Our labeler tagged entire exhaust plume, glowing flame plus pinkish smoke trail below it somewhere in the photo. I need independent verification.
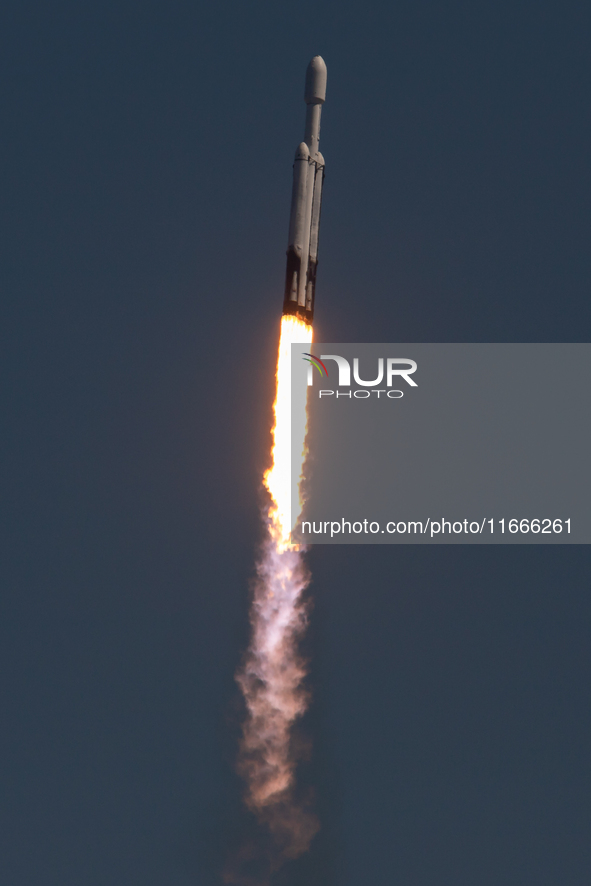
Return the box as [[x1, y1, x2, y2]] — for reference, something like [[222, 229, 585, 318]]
[[236, 316, 318, 869]]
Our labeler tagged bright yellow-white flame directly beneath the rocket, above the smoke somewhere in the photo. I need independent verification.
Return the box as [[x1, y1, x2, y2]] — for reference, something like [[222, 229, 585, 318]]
[[264, 316, 312, 551]]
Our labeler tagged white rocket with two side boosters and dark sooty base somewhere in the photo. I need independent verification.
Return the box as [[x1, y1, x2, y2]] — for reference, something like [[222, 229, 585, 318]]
[[283, 55, 326, 324]]
